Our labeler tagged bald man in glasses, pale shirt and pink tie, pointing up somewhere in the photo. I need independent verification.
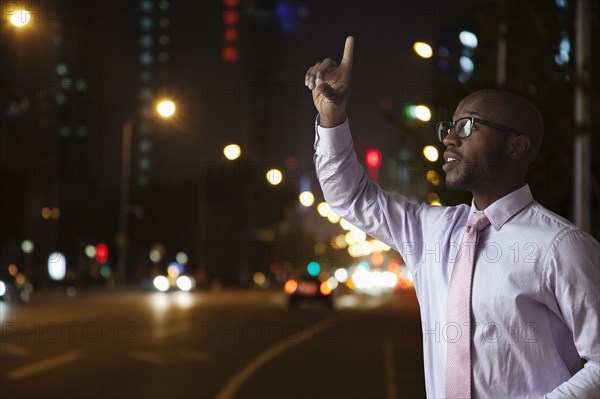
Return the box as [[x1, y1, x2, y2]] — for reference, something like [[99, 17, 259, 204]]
[[305, 37, 600, 398]]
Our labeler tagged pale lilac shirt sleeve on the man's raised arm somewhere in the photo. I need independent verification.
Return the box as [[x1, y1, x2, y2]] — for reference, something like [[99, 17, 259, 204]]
[[314, 117, 440, 267]]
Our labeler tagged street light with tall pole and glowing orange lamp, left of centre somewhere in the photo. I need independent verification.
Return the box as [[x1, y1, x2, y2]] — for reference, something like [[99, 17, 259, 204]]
[[117, 100, 175, 282]]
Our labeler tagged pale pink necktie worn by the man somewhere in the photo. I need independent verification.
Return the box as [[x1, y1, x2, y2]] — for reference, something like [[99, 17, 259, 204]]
[[446, 211, 490, 399]]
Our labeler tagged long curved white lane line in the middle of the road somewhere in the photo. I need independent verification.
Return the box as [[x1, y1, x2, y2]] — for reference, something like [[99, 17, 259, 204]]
[[216, 320, 331, 399]]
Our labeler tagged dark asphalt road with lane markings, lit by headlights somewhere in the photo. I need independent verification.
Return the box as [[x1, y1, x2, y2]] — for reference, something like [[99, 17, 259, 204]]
[[0, 291, 425, 399]]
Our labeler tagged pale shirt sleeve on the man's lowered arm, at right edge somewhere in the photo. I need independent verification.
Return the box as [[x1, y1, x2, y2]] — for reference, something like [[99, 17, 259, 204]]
[[545, 230, 600, 399]]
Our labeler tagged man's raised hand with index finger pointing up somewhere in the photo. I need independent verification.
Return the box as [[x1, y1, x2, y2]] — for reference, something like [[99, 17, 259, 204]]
[[304, 36, 354, 127]]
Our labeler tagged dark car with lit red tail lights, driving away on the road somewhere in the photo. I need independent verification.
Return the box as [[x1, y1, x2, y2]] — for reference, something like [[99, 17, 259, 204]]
[[284, 276, 333, 309]]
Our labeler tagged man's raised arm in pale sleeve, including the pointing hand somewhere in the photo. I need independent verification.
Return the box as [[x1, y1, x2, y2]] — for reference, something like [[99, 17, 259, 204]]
[[305, 37, 448, 265]]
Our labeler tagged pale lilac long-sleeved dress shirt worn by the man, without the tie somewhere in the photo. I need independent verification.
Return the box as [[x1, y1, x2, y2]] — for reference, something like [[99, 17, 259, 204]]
[[314, 120, 600, 398]]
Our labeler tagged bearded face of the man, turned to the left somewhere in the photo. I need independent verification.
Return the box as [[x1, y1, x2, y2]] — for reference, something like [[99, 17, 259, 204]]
[[442, 97, 507, 191]]
